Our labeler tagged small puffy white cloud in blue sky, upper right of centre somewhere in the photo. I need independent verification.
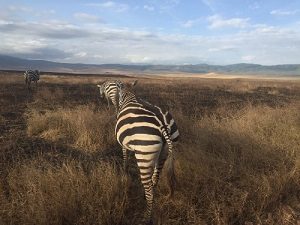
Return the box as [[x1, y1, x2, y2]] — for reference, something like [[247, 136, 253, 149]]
[[207, 15, 250, 29]]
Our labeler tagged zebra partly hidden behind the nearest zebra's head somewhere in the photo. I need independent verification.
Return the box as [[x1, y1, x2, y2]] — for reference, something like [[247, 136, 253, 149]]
[[97, 80, 124, 108]]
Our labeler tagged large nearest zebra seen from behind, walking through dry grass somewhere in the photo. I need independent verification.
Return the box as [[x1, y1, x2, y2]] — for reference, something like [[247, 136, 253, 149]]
[[98, 81, 179, 223]]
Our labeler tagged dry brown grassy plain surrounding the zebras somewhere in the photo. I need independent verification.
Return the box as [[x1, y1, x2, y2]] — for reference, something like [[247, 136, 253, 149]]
[[0, 72, 300, 225]]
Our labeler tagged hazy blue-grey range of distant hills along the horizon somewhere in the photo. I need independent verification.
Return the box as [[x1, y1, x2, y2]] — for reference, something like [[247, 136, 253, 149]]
[[0, 55, 300, 76]]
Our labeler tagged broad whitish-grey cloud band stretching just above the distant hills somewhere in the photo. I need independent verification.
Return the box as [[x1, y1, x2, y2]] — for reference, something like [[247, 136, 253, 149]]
[[0, 15, 300, 64]]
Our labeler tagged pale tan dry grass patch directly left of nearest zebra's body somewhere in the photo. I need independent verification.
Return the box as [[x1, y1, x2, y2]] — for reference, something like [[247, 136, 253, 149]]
[[27, 105, 115, 152]]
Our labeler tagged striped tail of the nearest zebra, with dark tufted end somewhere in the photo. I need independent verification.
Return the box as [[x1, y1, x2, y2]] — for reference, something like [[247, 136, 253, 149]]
[[162, 129, 177, 198]]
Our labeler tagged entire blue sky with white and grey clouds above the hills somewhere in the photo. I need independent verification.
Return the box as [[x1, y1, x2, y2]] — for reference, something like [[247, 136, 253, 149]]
[[0, 0, 300, 65]]
